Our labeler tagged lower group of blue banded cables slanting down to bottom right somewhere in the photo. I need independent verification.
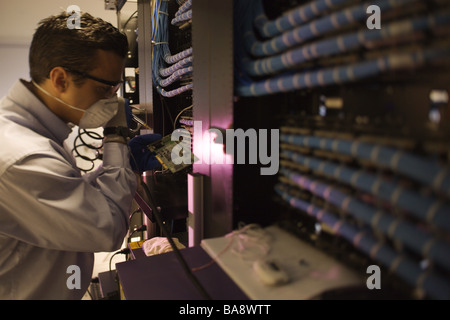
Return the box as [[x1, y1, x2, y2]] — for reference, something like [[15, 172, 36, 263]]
[[275, 127, 450, 299]]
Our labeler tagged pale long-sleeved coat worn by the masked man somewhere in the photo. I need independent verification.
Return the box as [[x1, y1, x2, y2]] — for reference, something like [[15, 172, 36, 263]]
[[0, 80, 137, 299]]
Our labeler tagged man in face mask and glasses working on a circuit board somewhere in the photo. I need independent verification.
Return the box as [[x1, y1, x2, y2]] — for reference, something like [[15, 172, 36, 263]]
[[0, 13, 160, 299]]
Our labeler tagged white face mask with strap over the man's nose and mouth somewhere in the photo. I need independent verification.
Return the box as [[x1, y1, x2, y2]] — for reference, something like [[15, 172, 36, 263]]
[[32, 81, 118, 129]]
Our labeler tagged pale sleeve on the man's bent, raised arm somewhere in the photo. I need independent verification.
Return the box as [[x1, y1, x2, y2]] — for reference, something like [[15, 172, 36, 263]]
[[0, 143, 136, 252]]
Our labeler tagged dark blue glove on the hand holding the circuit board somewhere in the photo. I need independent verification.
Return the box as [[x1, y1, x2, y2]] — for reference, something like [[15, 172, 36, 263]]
[[128, 134, 162, 173]]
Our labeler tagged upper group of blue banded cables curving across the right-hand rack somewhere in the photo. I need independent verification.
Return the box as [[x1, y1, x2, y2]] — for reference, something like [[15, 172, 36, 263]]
[[235, 0, 450, 96]]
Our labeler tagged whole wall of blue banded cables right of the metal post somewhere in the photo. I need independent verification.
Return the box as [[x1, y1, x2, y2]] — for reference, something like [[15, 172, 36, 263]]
[[234, 0, 450, 299]]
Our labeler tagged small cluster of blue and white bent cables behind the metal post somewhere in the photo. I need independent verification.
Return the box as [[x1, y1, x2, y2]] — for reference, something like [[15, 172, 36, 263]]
[[152, 0, 193, 97]]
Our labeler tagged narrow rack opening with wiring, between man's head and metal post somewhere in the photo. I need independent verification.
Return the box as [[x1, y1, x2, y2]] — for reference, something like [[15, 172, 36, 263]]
[[151, 0, 193, 139]]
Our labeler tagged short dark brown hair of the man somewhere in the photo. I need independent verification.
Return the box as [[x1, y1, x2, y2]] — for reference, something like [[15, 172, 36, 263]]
[[29, 12, 128, 85]]
